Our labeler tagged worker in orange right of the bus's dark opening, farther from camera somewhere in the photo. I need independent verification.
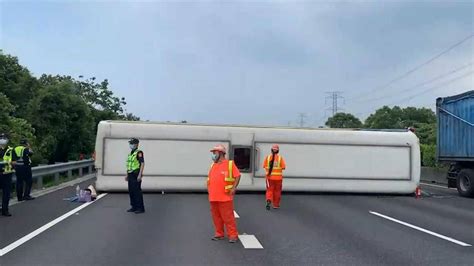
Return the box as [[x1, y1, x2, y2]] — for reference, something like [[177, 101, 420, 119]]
[[263, 144, 286, 210]]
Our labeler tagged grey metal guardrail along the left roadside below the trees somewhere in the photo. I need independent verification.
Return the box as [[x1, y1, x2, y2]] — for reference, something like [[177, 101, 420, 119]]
[[14, 160, 94, 189]]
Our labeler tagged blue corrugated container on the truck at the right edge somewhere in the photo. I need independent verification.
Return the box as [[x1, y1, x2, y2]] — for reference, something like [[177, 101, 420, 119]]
[[436, 91, 474, 161]]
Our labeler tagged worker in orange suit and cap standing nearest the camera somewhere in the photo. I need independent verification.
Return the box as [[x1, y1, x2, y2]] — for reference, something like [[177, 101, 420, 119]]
[[207, 145, 240, 243]]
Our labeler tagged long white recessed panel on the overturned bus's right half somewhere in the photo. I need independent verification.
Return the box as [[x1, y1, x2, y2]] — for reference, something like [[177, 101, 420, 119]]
[[255, 143, 411, 180]]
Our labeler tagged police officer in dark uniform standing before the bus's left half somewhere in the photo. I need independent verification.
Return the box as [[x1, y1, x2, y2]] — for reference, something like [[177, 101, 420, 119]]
[[125, 138, 145, 213]]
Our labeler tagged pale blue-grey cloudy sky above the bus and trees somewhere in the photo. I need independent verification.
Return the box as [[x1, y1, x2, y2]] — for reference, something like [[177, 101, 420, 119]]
[[0, 0, 474, 127]]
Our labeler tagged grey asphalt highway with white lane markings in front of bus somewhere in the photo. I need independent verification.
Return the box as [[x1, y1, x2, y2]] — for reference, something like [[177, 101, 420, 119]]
[[0, 182, 474, 266]]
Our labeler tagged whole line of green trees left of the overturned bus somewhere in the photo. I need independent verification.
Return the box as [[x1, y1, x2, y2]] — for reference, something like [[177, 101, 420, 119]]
[[0, 50, 139, 164]]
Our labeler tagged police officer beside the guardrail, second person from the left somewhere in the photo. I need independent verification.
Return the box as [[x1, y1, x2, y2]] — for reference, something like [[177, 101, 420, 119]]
[[15, 139, 35, 201]]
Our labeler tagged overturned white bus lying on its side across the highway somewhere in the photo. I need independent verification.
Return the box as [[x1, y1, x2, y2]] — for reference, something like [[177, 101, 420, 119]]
[[95, 121, 420, 194]]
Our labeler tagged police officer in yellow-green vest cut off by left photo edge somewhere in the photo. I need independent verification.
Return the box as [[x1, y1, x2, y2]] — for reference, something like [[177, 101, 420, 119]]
[[0, 133, 17, 216]]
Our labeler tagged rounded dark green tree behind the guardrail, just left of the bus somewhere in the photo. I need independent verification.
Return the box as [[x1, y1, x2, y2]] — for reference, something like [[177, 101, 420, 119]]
[[30, 80, 95, 163]]
